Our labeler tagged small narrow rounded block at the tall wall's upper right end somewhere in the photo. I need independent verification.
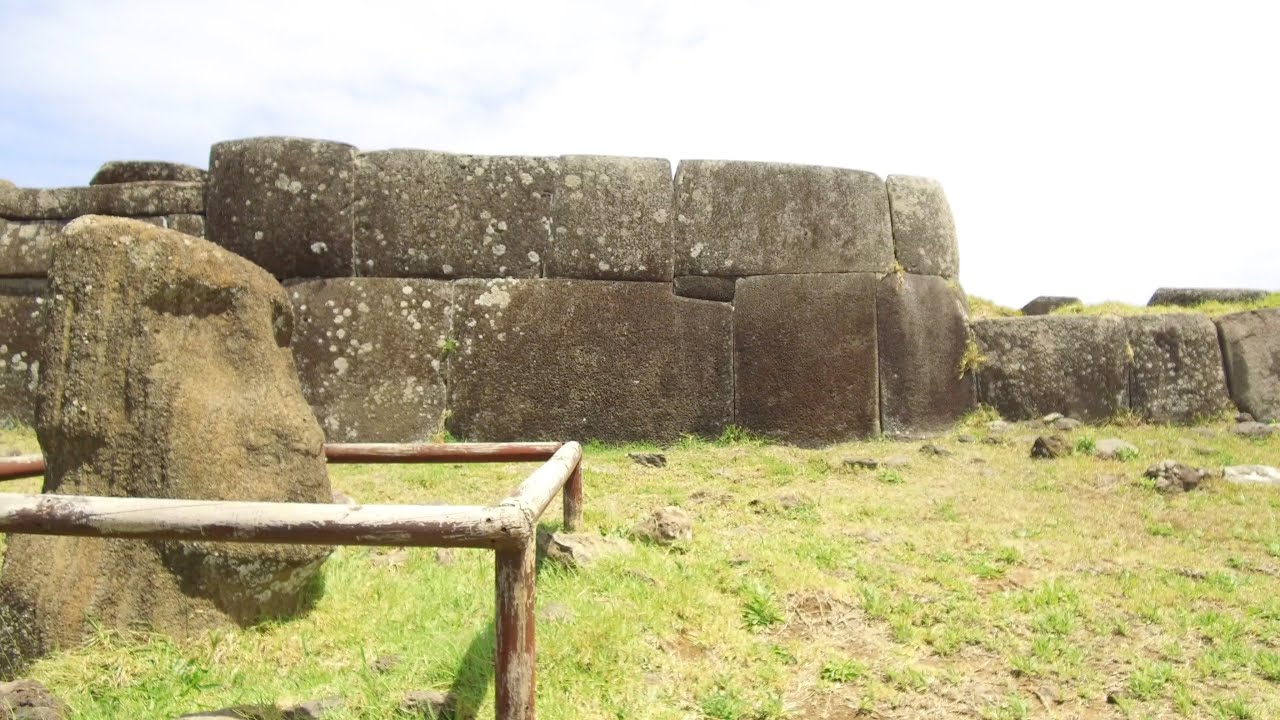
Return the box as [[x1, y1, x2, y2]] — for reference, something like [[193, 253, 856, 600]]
[[884, 176, 960, 278]]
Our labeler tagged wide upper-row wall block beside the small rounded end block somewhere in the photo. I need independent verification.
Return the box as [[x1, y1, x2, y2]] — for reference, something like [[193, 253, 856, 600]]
[[675, 160, 893, 275]]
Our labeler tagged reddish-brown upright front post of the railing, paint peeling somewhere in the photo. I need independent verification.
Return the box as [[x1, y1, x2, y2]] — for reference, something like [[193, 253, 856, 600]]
[[494, 541, 538, 720]]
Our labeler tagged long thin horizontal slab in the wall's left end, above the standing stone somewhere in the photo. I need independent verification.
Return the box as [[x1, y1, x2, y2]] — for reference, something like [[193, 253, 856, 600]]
[[0, 182, 205, 220]]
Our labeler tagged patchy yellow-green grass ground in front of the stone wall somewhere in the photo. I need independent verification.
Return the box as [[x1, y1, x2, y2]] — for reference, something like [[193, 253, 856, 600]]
[[0, 414, 1280, 720]]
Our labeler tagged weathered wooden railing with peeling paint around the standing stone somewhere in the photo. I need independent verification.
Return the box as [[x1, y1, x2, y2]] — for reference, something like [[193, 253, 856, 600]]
[[0, 442, 582, 720]]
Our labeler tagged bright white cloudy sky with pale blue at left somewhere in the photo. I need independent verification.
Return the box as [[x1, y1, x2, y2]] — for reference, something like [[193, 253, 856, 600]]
[[0, 0, 1280, 307]]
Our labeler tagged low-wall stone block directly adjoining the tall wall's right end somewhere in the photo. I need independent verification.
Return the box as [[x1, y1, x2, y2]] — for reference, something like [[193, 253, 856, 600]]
[[973, 315, 1129, 421]]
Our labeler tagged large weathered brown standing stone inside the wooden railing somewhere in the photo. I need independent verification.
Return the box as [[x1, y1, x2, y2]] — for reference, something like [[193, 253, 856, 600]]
[[0, 217, 330, 676]]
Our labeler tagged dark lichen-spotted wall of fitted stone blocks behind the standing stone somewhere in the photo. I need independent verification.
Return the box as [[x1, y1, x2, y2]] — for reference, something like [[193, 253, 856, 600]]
[[0, 132, 1261, 445]]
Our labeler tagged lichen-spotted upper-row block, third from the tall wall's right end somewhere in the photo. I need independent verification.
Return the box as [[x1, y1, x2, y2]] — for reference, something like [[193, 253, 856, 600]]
[[545, 155, 673, 281]]
